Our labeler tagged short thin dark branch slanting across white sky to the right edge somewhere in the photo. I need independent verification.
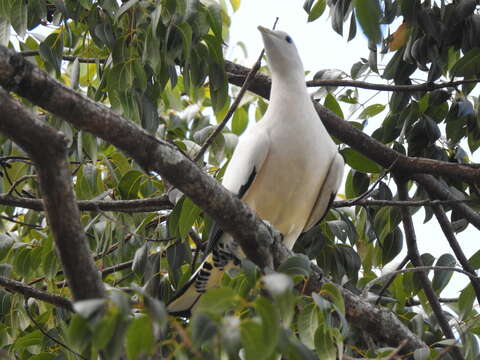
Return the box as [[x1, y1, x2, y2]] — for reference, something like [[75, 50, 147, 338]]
[[433, 205, 480, 305]]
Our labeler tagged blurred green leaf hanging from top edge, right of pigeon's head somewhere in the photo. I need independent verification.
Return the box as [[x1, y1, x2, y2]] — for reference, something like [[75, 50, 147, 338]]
[[354, 0, 382, 44]]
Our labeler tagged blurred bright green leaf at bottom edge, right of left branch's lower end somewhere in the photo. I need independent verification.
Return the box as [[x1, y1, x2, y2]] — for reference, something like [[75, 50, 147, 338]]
[[126, 315, 154, 360]]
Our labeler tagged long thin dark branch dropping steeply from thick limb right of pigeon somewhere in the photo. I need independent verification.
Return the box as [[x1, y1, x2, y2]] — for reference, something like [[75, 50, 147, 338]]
[[396, 179, 463, 360]]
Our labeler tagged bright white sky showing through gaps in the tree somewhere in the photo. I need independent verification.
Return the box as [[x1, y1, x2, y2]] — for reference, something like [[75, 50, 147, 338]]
[[226, 0, 480, 297]]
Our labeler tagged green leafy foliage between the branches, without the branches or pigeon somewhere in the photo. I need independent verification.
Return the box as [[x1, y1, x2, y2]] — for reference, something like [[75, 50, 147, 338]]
[[0, 0, 480, 359]]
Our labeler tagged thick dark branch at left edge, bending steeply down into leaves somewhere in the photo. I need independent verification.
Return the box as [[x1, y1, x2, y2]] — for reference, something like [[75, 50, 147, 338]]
[[0, 89, 105, 300]]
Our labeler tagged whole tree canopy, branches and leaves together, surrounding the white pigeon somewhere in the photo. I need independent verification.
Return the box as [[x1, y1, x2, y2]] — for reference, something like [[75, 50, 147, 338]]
[[0, 0, 480, 360]]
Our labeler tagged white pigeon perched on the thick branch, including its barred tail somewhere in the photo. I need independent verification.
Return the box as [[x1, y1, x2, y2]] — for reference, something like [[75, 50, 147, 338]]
[[167, 26, 344, 315]]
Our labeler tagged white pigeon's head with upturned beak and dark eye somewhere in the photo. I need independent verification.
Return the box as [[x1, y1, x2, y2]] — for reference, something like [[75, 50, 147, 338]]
[[258, 26, 305, 81]]
